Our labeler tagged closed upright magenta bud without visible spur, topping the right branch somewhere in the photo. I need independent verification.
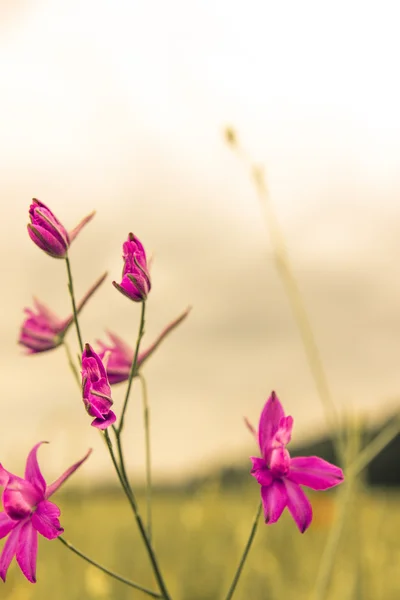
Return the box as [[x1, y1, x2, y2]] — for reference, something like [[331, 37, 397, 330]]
[[113, 233, 151, 302]]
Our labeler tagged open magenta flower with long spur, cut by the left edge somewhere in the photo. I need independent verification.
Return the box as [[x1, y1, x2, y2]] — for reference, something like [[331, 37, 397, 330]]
[[0, 442, 91, 583]]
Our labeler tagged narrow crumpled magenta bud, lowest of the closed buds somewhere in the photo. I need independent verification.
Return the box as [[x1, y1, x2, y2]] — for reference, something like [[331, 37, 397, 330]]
[[82, 344, 116, 429]]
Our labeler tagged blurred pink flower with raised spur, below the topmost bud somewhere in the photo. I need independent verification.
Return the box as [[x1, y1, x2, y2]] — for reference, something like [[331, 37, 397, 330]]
[[18, 273, 107, 354]]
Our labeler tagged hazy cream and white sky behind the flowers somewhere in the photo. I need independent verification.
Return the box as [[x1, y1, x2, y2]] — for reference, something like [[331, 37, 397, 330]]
[[0, 0, 400, 476]]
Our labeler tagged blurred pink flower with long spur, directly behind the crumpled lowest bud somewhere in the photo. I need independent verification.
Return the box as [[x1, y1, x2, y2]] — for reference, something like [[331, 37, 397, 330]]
[[98, 308, 190, 385]]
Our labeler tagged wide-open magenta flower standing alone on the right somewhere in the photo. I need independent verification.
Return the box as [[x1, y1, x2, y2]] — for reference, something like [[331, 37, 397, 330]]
[[250, 392, 343, 533]]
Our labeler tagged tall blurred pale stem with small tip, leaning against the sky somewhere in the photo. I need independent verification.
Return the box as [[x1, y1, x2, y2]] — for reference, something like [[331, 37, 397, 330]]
[[225, 128, 344, 461]]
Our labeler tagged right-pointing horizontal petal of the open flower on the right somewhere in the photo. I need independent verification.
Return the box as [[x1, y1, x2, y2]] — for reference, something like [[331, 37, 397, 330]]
[[287, 456, 344, 490]]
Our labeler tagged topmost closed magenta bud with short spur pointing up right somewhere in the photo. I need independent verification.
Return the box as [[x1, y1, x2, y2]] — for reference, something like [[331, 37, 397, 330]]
[[28, 198, 95, 258]]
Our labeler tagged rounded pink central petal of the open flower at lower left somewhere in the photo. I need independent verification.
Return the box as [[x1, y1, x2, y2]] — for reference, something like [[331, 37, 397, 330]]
[[3, 474, 42, 519]]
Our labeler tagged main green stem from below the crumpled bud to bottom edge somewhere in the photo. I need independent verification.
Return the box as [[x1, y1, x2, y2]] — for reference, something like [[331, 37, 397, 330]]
[[104, 428, 171, 600]]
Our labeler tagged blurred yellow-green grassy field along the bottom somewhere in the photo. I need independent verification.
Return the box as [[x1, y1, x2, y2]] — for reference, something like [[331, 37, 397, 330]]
[[0, 481, 400, 600]]
